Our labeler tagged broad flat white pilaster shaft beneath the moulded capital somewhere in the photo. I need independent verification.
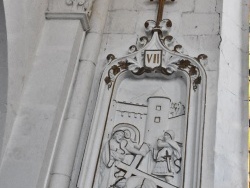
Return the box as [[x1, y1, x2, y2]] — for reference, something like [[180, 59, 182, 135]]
[[0, 8, 85, 188]]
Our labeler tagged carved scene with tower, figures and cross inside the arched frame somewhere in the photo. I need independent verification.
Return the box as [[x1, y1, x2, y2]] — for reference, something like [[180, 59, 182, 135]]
[[96, 78, 187, 187]]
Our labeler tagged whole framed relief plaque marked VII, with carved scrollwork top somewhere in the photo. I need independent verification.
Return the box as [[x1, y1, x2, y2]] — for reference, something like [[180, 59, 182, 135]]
[[79, 15, 206, 188]]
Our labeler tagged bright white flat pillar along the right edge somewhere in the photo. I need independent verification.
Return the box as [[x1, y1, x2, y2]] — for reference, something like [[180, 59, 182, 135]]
[[214, 0, 249, 188]]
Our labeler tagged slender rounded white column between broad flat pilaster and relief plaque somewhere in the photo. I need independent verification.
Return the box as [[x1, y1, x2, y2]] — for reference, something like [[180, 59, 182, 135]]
[[45, 0, 109, 188]]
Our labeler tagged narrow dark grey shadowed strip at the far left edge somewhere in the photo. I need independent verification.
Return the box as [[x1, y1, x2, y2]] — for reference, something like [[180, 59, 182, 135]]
[[0, 1, 8, 162]]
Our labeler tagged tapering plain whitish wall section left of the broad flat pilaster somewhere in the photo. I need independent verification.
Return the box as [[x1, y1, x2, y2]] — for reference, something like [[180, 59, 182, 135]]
[[4, 0, 48, 156]]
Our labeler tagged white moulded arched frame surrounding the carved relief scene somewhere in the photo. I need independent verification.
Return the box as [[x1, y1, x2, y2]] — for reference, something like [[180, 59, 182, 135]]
[[79, 25, 207, 188]]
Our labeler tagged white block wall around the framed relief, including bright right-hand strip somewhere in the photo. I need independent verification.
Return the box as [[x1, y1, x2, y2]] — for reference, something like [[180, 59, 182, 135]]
[[72, 0, 248, 188]]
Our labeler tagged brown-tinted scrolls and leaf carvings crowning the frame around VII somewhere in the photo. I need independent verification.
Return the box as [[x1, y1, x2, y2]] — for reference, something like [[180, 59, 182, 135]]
[[105, 19, 207, 91]]
